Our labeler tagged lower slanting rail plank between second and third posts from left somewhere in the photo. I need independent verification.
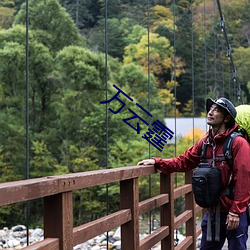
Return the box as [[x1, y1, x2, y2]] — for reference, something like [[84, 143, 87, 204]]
[[140, 226, 169, 250]]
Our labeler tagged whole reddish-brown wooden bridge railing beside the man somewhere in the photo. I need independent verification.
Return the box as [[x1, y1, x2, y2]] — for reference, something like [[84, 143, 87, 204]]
[[0, 166, 201, 250]]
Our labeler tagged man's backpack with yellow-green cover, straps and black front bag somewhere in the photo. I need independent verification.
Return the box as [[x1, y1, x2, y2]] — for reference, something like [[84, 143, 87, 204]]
[[192, 105, 250, 241]]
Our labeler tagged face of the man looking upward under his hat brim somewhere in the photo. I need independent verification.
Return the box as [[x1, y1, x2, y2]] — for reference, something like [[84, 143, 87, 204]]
[[207, 104, 225, 128]]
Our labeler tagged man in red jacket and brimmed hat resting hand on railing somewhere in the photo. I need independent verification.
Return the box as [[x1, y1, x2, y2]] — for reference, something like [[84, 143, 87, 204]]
[[138, 97, 250, 250]]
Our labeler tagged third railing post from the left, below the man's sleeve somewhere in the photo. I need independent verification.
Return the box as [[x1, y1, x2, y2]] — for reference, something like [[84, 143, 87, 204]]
[[160, 173, 174, 250]]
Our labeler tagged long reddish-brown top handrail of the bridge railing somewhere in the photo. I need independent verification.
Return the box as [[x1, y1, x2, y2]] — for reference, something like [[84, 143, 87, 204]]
[[0, 166, 156, 206]]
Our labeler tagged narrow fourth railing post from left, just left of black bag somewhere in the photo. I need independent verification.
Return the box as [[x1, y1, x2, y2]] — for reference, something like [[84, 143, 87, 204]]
[[185, 172, 196, 250]]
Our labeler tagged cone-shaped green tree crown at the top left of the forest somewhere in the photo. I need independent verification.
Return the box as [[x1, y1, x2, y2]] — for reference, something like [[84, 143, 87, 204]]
[[14, 0, 84, 52]]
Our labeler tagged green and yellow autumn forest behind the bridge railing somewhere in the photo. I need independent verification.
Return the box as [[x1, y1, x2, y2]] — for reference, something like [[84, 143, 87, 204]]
[[0, 0, 250, 228]]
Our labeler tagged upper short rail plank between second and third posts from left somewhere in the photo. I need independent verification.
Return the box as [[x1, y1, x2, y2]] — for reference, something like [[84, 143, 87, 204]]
[[139, 194, 169, 215]]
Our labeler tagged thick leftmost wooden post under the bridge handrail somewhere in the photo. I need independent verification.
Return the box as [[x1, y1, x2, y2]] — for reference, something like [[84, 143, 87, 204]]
[[44, 192, 73, 250]]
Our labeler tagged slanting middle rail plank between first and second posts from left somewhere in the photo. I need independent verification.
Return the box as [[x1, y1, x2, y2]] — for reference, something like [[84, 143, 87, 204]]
[[73, 209, 131, 246]]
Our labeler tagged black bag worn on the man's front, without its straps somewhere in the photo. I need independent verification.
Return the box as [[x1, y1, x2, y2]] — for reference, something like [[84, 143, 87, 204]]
[[192, 163, 221, 208]]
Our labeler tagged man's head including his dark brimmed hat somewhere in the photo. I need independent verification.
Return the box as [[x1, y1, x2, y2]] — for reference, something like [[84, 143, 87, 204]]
[[206, 97, 237, 128]]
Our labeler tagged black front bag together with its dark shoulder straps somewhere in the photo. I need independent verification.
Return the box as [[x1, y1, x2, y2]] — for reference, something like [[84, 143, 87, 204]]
[[192, 132, 242, 208]]
